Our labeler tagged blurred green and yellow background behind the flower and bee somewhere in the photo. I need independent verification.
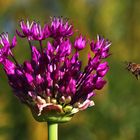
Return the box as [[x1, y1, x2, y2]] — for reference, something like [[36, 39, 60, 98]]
[[0, 0, 140, 140]]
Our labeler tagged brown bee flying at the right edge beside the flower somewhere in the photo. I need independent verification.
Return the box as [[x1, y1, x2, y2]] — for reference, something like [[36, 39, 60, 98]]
[[126, 62, 140, 80]]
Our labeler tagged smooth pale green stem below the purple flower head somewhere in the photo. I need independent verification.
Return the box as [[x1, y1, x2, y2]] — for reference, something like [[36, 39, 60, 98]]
[[48, 122, 58, 140]]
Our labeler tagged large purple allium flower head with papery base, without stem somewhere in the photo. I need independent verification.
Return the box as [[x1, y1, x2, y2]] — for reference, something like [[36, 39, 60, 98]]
[[0, 17, 111, 121]]
